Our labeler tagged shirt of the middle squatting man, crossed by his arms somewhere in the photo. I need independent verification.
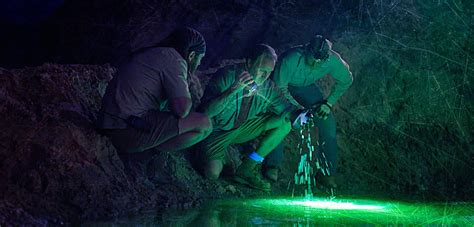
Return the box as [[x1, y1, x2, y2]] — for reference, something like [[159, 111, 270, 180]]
[[202, 64, 293, 130]]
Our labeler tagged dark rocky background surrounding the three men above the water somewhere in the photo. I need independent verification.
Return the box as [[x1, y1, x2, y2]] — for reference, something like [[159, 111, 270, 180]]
[[0, 0, 474, 223]]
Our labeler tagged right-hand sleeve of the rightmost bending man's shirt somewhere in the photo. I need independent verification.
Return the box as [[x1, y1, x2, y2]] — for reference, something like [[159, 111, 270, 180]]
[[327, 53, 353, 104]]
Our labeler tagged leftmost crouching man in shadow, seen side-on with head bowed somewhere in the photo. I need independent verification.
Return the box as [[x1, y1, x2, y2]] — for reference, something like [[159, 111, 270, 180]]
[[98, 28, 211, 153]]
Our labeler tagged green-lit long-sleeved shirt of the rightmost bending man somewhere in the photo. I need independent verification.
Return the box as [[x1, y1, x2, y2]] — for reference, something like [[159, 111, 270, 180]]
[[273, 46, 353, 107]]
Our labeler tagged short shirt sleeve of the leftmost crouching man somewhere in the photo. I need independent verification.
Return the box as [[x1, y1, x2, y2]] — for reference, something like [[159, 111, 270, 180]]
[[162, 59, 191, 99]]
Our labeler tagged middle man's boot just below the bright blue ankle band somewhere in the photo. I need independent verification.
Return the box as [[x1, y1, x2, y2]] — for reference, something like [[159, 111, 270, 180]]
[[234, 158, 271, 192]]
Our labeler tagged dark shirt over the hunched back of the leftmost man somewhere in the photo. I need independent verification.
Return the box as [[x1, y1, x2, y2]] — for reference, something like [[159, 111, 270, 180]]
[[100, 47, 190, 128]]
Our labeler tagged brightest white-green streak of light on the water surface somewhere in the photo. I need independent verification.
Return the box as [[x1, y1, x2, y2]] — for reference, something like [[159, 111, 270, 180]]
[[289, 201, 383, 210]]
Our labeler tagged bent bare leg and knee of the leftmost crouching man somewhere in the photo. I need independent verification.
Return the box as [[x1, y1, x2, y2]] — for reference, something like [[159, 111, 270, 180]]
[[157, 112, 212, 151]]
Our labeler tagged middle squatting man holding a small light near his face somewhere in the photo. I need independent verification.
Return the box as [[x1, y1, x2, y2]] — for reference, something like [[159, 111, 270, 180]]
[[199, 44, 292, 191]]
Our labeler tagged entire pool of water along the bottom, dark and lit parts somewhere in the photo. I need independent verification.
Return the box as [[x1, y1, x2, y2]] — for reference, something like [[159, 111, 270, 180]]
[[85, 198, 474, 227]]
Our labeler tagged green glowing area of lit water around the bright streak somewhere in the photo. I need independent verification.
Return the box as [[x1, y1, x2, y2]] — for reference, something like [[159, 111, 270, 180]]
[[218, 198, 474, 226]]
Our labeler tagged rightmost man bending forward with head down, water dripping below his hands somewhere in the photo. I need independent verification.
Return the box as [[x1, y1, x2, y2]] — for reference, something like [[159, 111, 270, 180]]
[[266, 35, 353, 188]]
